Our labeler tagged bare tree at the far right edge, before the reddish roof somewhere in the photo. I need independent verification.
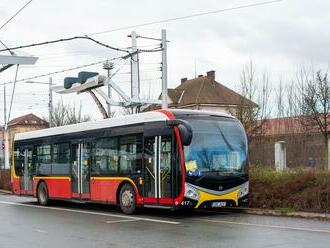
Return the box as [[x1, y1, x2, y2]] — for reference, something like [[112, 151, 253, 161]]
[[300, 71, 330, 170]]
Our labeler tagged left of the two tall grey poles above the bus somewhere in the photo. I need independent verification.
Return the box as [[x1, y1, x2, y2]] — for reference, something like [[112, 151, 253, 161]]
[[130, 31, 140, 101]]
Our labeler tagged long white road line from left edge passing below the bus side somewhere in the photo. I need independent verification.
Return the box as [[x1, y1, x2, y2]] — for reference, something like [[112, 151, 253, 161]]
[[0, 201, 181, 225]]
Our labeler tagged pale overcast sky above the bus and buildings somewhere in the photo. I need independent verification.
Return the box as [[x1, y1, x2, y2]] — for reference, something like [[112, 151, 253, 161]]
[[0, 0, 330, 123]]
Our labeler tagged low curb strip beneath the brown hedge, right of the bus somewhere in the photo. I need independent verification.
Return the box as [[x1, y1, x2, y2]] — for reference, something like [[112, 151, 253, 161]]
[[240, 208, 330, 220]]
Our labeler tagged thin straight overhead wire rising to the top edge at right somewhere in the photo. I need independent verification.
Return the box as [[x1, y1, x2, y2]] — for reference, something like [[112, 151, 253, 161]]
[[87, 0, 283, 36]]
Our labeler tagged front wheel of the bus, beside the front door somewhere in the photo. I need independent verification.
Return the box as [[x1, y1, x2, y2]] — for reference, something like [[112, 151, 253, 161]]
[[119, 183, 136, 214]]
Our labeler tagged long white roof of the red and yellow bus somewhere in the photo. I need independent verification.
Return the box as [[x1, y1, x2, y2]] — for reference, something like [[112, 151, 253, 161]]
[[14, 109, 233, 141]]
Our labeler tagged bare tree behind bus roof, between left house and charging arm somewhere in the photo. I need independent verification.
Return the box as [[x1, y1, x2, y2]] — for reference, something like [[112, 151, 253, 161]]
[[47, 101, 91, 127]]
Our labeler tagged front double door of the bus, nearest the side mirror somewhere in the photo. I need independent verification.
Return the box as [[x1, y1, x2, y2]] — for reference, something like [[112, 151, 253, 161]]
[[144, 136, 174, 206]]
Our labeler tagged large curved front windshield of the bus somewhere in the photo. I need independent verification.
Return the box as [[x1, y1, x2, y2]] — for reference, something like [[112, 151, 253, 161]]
[[184, 117, 247, 176]]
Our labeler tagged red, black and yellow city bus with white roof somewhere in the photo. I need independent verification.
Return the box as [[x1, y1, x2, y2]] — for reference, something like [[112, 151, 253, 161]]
[[12, 110, 249, 214]]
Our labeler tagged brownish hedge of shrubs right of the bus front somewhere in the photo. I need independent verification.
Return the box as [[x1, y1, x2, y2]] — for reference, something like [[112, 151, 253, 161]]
[[250, 166, 330, 212]]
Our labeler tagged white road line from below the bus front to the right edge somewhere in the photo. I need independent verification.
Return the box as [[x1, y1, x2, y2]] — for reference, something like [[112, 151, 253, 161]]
[[195, 219, 330, 233]]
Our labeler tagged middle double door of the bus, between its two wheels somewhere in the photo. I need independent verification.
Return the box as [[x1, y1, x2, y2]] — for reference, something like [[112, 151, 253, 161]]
[[71, 143, 90, 200]]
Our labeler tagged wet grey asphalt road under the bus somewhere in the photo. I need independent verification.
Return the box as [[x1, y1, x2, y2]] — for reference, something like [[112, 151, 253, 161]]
[[0, 195, 330, 248]]
